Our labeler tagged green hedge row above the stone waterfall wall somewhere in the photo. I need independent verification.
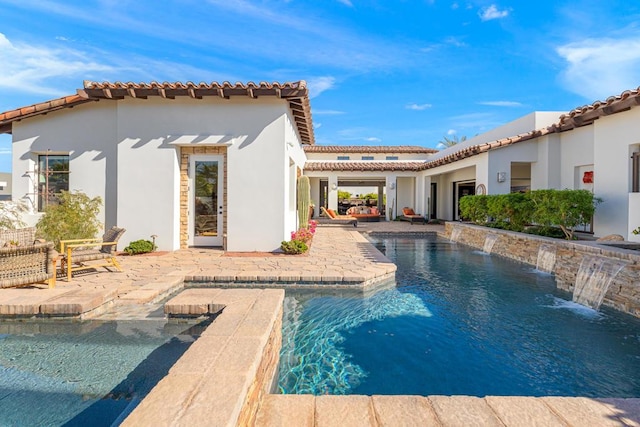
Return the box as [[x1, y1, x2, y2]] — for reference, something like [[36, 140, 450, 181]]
[[460, 190, 602, 240]]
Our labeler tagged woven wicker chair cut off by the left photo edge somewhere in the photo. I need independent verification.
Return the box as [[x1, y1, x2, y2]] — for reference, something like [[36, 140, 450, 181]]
[[0, 227, 58, 288]]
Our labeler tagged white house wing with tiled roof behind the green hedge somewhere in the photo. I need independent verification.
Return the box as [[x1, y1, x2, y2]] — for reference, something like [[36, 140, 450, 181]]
[[304, 88, 640, 241]]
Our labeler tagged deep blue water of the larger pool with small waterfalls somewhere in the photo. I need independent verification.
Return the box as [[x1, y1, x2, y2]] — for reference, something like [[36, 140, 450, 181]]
[[279, 237, 640, 397]]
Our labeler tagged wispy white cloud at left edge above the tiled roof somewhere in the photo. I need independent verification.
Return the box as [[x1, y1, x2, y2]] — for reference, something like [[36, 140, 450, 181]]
[[0, 33, 114, 96]]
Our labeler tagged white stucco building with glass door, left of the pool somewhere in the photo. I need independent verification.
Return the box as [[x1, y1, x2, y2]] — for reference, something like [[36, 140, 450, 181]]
[[0, 81, 314, 251]]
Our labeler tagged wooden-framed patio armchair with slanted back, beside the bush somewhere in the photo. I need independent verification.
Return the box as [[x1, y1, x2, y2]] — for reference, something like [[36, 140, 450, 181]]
[[60, 227, 126, 282]]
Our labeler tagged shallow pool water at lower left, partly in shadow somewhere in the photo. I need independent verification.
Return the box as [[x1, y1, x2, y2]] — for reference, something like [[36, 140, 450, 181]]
[[0, 319, 208, 426]]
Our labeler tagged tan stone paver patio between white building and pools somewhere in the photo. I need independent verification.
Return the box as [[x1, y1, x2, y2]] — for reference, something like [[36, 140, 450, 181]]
[[0, 222, 430, 317]]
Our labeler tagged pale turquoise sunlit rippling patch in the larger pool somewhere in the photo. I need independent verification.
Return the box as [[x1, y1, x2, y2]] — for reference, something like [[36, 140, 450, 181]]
[[279, 289, 432, 395]]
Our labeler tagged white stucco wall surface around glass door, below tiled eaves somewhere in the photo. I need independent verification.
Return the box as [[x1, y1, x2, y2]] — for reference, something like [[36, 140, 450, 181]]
[[13, 97, 305, 251]]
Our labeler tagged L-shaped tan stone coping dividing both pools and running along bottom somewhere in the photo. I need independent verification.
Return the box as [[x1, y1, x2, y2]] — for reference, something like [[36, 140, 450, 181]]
[[122, 288, 640, 427]]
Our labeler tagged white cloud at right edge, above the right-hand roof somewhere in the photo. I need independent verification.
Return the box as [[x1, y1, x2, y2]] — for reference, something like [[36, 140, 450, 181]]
[[556, 34, 640, 100]]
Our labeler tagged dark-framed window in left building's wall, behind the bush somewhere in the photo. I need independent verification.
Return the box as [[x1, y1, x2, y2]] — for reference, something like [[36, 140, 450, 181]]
[[38, 154, 69, 212]]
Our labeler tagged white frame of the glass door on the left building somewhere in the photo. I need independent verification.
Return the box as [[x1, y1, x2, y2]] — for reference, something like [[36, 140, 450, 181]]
[[187, 154, 225, 246]]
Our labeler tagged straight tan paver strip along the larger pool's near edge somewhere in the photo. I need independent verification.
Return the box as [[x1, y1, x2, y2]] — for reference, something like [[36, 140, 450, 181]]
[[256, 394, 640, 427]]
